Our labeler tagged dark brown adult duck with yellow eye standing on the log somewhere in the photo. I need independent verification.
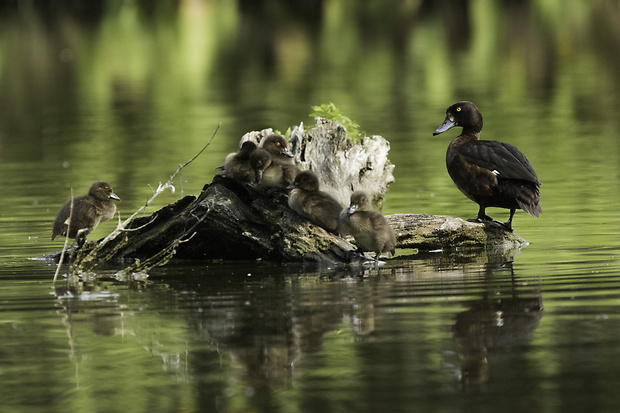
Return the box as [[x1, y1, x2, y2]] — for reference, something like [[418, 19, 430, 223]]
[[433, 101, 541, 231]]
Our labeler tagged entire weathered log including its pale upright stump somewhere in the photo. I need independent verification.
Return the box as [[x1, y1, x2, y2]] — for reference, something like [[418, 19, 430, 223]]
[[51, 119, 526, 273]]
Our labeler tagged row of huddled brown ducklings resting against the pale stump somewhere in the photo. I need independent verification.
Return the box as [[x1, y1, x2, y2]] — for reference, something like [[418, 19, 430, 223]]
[[224, 134, 396, 260]]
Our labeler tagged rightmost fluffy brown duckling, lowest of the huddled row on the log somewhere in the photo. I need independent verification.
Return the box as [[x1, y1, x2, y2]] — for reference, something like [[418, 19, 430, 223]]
[[340, 191, 396, 262]]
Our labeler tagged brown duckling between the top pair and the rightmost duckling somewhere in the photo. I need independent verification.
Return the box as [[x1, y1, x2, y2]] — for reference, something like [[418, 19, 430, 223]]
[[288, 171, 342, 234]]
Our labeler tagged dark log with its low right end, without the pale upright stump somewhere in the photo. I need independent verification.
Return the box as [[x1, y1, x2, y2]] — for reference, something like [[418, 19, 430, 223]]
[[57, 175, 526, 272]]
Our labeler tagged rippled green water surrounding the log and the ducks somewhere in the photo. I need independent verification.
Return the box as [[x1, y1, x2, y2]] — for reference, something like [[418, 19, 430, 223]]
[[0, 0, 620, 412]]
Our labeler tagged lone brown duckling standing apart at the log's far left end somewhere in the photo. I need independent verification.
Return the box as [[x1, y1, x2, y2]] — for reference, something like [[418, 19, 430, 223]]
[[52, 181, 120, 248]]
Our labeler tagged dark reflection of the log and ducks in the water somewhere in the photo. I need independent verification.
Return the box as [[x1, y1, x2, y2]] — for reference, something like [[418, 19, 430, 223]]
[[46, 246, 542, 408]]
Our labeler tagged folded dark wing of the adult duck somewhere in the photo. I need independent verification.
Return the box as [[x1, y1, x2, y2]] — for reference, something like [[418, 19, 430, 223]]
[[459, 141, 540, 185]]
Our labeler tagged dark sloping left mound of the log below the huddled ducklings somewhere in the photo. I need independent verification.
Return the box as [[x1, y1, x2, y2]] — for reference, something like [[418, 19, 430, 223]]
[[63, 175, 352, 271]]
